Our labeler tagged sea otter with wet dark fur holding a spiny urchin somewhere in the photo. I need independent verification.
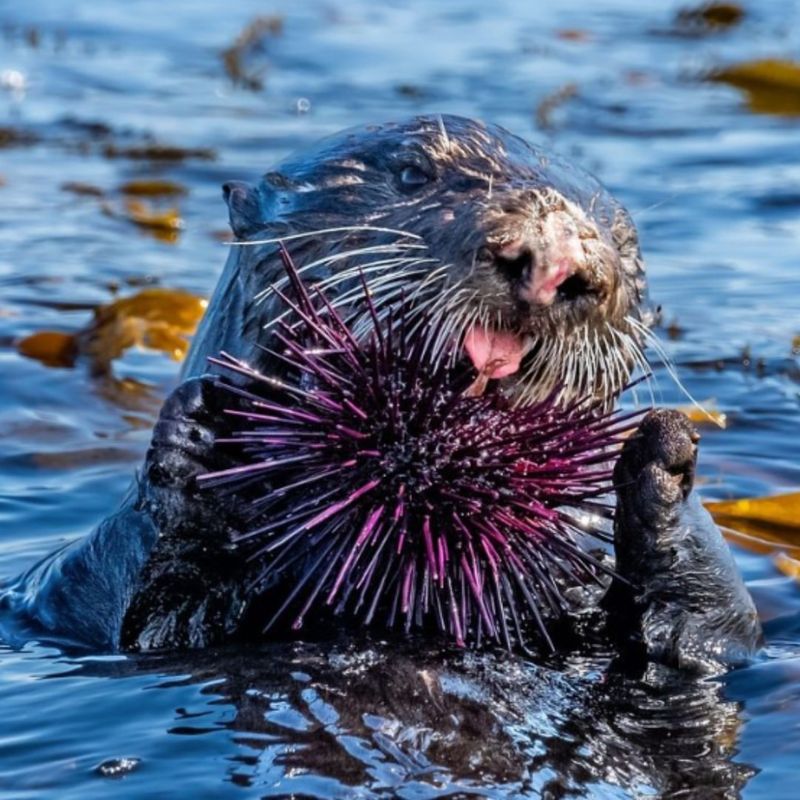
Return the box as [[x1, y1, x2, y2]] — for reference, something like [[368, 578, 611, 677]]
[[0, 116, 758, 665]]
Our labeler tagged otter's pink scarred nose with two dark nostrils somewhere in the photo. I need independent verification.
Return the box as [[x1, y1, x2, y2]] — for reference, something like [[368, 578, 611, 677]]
[[492, 239, 596, 306]]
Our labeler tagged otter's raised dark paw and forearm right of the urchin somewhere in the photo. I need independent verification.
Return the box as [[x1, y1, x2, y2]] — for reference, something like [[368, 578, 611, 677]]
[[604, 409, 761, 671]]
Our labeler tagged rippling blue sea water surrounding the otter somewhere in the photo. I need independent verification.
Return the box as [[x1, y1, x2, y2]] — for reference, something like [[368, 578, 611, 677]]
[[0, 0, 800, 799]]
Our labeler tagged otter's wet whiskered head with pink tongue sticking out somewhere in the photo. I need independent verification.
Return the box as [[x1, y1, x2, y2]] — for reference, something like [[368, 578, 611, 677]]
[[216, 116, 645, 403]]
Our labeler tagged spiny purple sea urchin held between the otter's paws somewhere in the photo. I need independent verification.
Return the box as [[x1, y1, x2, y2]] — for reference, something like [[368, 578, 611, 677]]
[[202, 251, 632, 647]]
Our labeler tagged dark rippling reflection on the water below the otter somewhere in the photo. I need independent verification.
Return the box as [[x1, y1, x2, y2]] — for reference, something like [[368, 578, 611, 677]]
[[51, 642, 755, 798]]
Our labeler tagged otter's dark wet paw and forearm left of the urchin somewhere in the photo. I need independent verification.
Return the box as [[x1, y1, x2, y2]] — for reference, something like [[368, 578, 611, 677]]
[[120, 376, 248, 650]]
